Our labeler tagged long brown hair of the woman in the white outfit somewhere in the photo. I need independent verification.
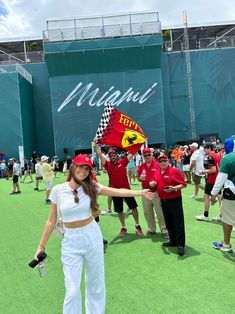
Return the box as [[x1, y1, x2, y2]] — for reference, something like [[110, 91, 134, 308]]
[[67, 164, 100, 217]]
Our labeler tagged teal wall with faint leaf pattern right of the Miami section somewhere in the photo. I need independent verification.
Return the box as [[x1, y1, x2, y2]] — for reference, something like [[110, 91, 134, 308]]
[[162, 48, 235, 145]]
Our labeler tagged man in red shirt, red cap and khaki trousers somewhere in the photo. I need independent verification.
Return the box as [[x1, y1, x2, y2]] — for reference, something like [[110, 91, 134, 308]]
[[137, 148, 168, 238]]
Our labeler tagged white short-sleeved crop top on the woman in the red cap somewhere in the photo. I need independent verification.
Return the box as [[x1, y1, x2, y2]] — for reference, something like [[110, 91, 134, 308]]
[[49, 182, 102, 222]]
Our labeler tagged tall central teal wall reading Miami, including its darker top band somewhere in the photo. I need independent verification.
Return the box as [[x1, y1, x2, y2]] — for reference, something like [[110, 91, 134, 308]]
[[45, 36, 165, 156]]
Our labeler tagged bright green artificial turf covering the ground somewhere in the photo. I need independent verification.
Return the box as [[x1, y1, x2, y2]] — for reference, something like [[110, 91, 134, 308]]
[[0, 174, 235, 314]]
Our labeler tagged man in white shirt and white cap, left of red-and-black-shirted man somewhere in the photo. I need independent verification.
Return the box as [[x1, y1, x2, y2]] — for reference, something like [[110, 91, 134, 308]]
[[189, 143, 205, 200]]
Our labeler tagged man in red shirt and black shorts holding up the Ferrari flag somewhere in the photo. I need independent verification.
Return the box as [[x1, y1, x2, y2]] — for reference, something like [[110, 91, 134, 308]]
[[96, 145, 143, 237]]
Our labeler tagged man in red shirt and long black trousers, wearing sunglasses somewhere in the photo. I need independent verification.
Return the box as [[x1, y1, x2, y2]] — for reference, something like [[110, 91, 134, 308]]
[[149, 154, 187, 256]]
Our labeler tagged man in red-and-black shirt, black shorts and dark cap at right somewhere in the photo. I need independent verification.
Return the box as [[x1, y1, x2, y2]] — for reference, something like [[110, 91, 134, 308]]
[[195, 143, 221, 221]]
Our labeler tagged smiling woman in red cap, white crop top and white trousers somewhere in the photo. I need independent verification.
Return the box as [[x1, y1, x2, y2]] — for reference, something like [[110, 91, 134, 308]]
[[35, 155, 152, 314]]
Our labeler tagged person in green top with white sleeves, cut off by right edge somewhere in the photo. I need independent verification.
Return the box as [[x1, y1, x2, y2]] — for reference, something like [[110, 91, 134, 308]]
[[211, 137, 235, 253]]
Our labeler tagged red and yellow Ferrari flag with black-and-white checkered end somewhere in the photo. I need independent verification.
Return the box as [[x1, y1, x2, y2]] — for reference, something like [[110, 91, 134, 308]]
[[94, 104, 148, 154]]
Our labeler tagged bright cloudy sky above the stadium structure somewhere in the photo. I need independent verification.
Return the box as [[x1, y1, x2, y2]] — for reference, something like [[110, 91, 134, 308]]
[[0, 0, 235, 38]]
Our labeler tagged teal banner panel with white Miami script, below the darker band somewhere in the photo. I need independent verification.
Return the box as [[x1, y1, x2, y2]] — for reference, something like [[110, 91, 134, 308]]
[[50, 69, 165, 155]]
